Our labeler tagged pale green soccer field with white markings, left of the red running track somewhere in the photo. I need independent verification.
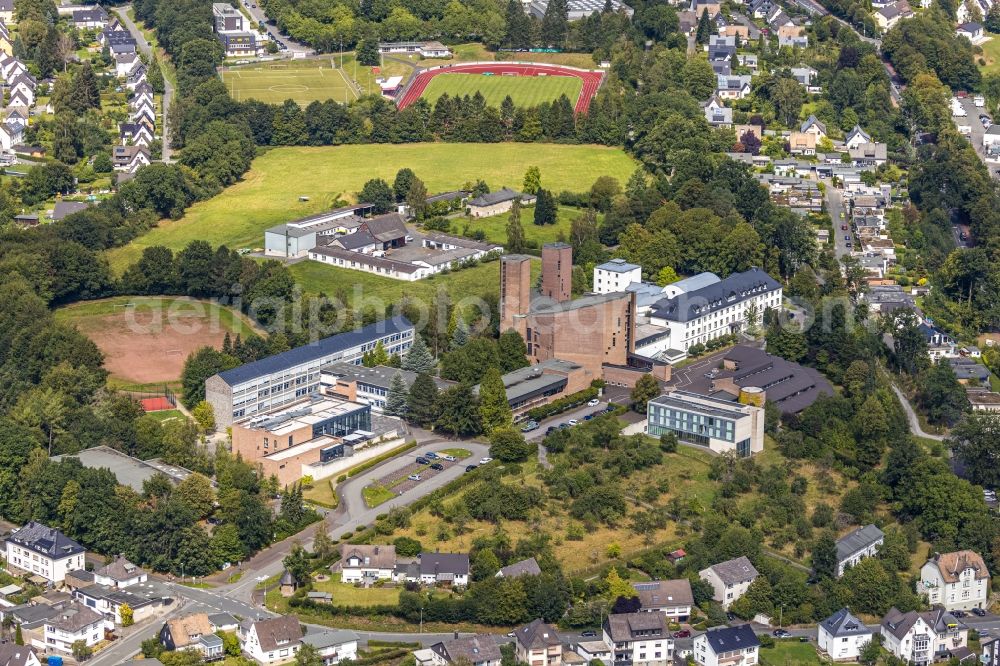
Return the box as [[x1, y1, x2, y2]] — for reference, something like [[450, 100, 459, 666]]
[[222, 59, 358, 106]]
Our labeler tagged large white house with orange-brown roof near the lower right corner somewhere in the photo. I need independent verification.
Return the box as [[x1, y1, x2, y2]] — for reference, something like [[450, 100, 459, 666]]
[[917, 550, 990, 610]]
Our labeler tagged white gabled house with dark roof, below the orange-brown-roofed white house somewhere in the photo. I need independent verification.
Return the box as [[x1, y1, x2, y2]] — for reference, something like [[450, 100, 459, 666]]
[[881, 607, 969, 666]]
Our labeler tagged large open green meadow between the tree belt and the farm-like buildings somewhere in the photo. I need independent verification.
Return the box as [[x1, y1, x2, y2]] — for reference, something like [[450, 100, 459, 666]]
[[108, 143, 636, 276]]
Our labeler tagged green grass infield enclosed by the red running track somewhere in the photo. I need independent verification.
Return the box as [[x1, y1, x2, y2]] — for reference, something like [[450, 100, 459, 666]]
[[423, 73, 583, 106]]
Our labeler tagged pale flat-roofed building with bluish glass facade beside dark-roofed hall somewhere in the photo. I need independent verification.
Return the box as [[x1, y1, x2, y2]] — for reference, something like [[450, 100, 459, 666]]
[[646, 390, 764, 457]]
